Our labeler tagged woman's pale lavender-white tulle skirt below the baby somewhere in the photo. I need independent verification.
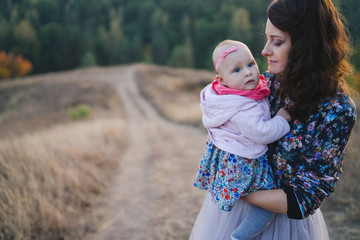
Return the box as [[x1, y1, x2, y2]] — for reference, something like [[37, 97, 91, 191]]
[[190, 193, 329, 240]]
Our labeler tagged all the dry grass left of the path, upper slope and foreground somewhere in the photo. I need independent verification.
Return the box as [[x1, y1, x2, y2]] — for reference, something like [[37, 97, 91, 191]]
[[0, 69, 126, 240]]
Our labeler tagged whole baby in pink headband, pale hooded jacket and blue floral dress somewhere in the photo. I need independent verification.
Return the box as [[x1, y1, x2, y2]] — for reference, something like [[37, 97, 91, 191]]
[[194, 40, 291, 240]]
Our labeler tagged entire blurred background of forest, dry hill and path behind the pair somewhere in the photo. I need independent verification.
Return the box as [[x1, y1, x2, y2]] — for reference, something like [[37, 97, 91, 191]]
[[0, 0, 360, 240]]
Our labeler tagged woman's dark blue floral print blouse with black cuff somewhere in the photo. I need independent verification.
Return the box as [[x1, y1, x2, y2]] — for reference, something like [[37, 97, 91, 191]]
[[264, 72, 356, 218]]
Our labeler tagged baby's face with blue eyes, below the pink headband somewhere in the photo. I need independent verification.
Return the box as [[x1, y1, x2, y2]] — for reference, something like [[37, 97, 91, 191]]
[[218, 48, 260, 90]]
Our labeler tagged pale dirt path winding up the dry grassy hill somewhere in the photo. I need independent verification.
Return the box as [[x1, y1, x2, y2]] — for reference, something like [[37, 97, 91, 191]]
[[86, 65, 205, 240]]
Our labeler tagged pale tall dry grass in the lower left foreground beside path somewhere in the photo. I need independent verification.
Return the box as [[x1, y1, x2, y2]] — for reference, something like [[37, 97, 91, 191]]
[[0, 119, 126, 240]]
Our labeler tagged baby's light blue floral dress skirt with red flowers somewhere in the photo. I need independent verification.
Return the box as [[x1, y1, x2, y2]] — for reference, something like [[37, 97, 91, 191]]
[[194, 137, 275, 211]]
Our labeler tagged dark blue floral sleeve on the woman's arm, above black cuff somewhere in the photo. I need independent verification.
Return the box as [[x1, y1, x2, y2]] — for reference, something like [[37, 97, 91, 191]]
[[286, 103, 355, 217]]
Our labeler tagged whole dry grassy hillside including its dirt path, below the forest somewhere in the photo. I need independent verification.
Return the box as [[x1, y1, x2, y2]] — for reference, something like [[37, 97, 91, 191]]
[[0, 64, 360, 240]]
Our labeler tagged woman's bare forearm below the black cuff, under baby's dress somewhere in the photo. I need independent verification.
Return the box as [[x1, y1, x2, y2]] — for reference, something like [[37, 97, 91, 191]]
[[243, 189, 288, 214]]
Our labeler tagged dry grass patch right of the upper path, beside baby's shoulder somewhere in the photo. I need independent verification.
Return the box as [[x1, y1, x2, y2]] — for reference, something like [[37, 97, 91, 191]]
[[137, 66, 214, 126]]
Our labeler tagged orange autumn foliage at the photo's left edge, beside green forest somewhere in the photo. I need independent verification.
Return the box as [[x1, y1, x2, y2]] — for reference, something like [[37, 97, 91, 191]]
[[0, 51, 32, 79]]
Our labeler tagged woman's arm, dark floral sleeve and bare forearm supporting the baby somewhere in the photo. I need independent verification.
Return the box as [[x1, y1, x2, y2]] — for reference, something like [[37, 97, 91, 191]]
[[244, 98, 356, 219]]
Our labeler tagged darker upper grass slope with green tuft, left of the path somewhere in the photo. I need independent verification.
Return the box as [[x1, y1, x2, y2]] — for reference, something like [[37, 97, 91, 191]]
[[0, 70, 124, 138]]
